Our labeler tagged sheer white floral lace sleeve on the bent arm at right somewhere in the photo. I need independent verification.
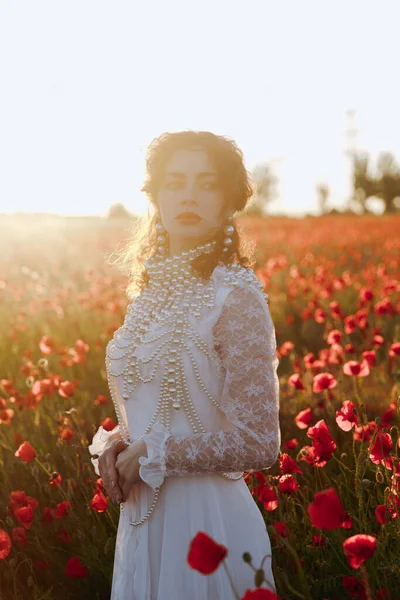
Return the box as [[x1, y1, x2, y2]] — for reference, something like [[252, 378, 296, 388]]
[[140, 285, 281, 483]]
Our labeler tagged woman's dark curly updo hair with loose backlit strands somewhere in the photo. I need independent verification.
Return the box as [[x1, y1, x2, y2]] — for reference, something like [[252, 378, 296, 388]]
[[104, 130, 256, 298]]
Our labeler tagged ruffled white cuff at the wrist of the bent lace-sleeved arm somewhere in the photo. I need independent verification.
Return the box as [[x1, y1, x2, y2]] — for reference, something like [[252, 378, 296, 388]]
[[139, 421, 171, 490]]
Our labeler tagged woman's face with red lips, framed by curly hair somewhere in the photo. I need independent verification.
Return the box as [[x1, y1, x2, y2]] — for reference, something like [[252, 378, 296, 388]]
[[158, 149, 227, 243]]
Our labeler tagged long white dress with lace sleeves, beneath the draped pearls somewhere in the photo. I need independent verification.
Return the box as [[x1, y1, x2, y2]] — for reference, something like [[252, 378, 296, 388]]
[[89, 265, 281, 600]]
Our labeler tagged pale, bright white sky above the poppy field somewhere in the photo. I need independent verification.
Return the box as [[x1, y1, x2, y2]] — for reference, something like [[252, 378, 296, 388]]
[[0, 0, 400, 216]]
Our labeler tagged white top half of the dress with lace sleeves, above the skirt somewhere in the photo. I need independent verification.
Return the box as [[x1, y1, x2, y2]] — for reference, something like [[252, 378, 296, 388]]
[[91, 265, 281, 489]]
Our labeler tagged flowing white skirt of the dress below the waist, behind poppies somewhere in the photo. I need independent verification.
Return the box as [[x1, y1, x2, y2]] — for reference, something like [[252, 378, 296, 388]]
[[111, 473, 275, 600]]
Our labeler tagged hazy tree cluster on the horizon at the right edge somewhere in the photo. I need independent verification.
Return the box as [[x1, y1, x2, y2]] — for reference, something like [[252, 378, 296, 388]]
[[353, 152, 400, 213]]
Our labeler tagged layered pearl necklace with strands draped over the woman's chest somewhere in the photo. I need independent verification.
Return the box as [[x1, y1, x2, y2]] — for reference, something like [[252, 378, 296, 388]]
[[106, 241, 267, 526]]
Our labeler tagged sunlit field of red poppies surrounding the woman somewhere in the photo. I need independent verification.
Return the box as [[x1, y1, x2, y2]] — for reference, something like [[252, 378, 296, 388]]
[[0, 215, 400, 600]]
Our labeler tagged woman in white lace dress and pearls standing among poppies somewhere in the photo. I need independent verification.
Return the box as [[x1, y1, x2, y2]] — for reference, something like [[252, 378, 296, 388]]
[[89, 131, 281, 600]]
